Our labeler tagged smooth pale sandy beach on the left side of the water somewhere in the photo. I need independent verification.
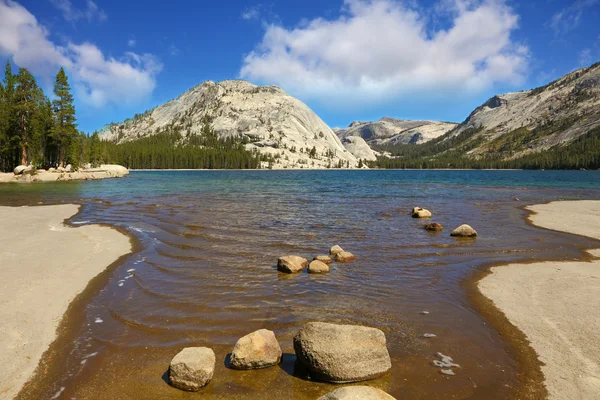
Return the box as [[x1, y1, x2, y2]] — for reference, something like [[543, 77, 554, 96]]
[[0, 204, 132, 399]]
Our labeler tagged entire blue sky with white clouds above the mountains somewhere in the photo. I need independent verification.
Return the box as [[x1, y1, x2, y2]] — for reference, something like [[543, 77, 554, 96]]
[[0, 0, 600, 133]]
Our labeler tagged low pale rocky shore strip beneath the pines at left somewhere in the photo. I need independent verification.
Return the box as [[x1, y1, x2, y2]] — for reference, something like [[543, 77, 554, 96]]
[[0, 164, 129, 183]]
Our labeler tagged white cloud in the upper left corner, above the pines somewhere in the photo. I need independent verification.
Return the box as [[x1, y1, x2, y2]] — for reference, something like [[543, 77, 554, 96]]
[[0, 0, 162, 107]]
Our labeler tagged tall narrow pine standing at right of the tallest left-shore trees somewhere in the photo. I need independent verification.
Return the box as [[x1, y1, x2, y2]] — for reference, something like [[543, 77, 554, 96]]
[[52, 68, 77, 167]]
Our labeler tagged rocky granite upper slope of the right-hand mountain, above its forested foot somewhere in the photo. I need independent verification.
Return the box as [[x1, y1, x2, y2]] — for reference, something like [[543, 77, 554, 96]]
[[445, 63, 600, 159]]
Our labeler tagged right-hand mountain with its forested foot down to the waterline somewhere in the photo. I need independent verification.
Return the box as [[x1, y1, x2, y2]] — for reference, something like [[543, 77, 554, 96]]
[[372, 63, 600, 169]]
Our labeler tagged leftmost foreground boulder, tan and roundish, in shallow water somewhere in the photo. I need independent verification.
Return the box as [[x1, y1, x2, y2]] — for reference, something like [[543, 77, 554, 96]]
[[169, 347, 215, 392]]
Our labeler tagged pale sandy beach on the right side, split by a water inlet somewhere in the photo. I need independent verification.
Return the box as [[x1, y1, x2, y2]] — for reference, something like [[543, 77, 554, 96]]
[[479, 200, 600, 400]]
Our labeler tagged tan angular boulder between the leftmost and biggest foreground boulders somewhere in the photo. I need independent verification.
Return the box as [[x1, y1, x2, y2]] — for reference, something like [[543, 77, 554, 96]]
[[231, 329, 282, 369]]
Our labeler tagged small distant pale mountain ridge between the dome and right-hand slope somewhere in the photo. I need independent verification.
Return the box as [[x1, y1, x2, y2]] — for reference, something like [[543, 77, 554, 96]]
[[336, 118, 457, 147]]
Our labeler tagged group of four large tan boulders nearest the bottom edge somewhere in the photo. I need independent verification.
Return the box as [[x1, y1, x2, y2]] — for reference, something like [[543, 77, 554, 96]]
[[169, 322, 394, 400]]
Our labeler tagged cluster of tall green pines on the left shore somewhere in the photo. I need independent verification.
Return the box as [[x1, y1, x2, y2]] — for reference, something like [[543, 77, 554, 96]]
[[0, 61, 101, 171]]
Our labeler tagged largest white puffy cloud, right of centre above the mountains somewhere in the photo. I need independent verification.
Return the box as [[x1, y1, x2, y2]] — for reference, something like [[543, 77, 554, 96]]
[[240, 0, 528, 104]]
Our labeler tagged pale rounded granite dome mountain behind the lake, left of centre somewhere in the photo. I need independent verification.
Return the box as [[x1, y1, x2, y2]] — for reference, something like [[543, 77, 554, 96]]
[[100, 80, 358, 168]]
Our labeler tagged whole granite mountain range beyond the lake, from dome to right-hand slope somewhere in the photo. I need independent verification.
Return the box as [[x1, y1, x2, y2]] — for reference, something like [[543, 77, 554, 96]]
[[101, 63, 600, 168]]
